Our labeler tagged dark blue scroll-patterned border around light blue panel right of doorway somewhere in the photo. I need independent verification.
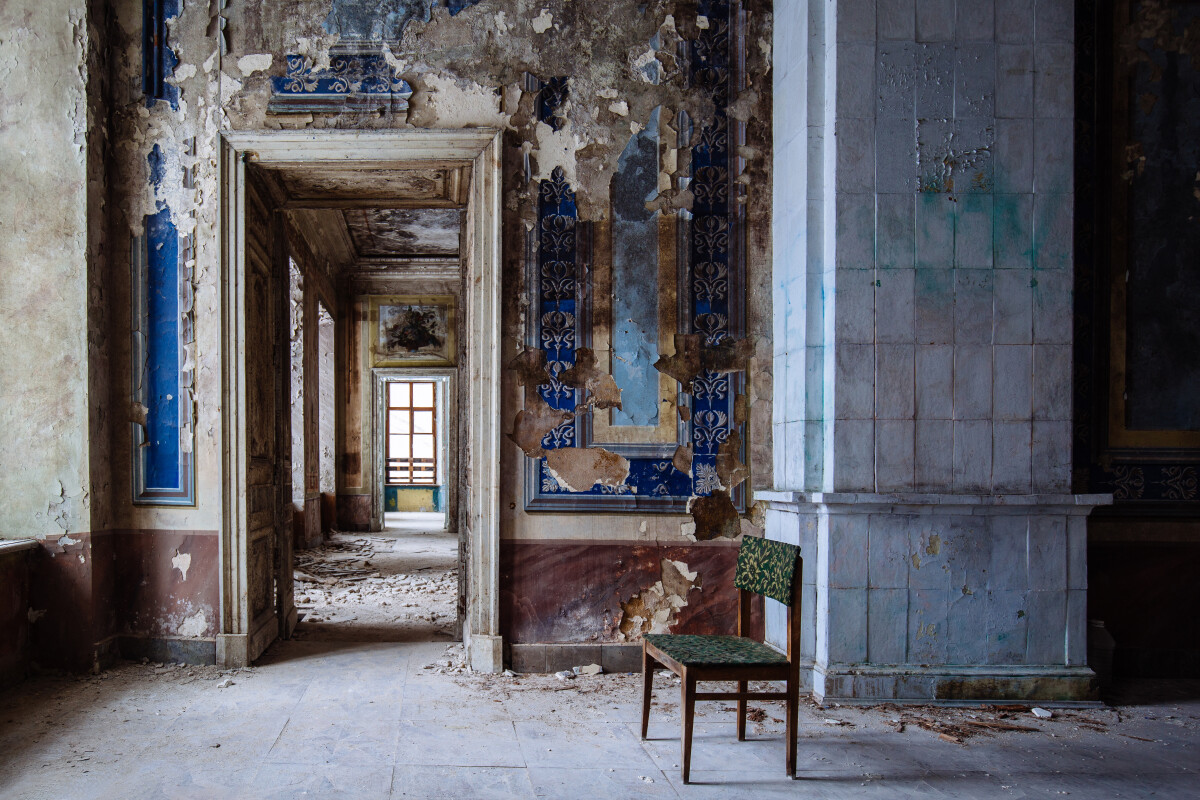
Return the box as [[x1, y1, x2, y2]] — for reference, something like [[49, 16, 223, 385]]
[[523, 0, 746, 513]]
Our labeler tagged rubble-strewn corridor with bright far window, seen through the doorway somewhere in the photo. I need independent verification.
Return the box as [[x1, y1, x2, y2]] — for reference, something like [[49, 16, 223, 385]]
[[287, 244, 463, 642]]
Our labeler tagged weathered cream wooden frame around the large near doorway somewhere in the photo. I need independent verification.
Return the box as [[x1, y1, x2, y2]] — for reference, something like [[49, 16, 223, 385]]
[[217, 128, 503, 672]]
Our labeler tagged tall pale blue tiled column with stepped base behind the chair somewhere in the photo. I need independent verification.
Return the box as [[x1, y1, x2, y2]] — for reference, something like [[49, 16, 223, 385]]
[[756, 0, 1108, 700]]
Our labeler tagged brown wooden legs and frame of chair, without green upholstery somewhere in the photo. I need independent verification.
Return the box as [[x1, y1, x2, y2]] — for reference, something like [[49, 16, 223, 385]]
[[642, 555, 803, 783]]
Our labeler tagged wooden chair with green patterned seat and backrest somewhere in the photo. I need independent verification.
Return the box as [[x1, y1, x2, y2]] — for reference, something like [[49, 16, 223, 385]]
[[642, 536, 803, 783]]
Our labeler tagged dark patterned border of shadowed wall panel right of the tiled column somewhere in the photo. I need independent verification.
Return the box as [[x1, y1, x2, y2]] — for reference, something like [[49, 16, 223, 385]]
[[1070, 0, 1200, 507]]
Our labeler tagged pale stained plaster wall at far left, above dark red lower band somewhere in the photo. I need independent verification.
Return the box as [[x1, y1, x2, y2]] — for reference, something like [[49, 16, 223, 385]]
[[0, 0, 103, 539]]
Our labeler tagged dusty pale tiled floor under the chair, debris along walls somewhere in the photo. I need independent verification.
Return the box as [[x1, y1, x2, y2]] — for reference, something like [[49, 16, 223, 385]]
[[0, 640, 1200, 800]]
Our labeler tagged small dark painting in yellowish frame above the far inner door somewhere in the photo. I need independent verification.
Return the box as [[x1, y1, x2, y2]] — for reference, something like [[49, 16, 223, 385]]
[[367, 295, 457, 367]]
